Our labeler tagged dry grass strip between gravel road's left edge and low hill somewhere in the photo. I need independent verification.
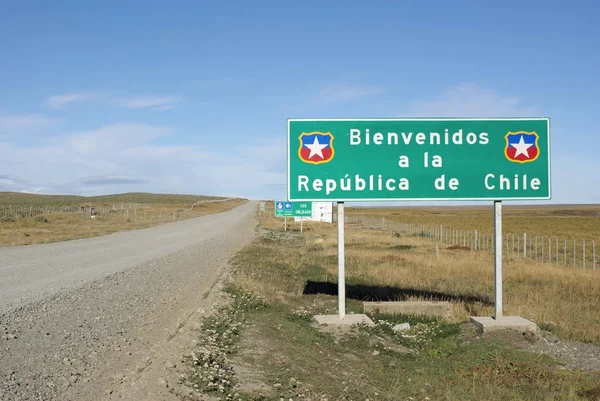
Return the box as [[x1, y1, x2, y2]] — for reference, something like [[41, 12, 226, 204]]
[[0, 197, 246, 246]]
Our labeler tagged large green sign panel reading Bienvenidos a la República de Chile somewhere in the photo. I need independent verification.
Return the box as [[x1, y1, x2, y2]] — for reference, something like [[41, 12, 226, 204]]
[[287, 118, 551, 202]]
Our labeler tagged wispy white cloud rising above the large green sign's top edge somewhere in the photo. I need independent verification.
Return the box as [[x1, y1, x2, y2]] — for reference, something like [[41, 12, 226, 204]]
[[400, 83, 537, 117]]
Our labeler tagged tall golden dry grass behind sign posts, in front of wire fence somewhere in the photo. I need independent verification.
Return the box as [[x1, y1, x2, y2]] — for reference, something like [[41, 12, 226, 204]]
[[260, 212, 600, 344]]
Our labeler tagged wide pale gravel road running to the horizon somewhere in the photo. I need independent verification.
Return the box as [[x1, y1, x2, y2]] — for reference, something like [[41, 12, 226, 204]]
[[0, 202, 255, 401]]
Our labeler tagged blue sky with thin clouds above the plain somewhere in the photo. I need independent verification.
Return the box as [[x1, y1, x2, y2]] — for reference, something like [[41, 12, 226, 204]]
[[0, 1, 600, 203]]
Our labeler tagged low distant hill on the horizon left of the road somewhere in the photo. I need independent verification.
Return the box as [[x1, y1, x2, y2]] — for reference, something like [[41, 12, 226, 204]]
[[0, 192, 231, 206]]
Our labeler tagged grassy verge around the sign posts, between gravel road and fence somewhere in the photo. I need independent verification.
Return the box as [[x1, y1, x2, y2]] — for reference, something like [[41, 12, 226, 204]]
[[184, 203, 600, 401]]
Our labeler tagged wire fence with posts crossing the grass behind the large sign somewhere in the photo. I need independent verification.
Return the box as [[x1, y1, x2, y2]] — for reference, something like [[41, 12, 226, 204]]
[[334, 215, 596, 270]]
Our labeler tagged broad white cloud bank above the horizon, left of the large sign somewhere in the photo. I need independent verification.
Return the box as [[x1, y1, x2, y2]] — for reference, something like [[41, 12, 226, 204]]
[[0, 124, 285, 197]]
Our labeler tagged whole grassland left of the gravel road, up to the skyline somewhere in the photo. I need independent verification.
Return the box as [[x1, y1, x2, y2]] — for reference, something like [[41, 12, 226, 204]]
[[0, 193, 246, 246]]
